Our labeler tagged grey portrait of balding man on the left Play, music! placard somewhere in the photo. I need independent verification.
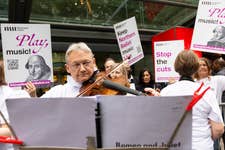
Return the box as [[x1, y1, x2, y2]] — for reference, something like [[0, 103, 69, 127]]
[[25, 55, 51, 82]]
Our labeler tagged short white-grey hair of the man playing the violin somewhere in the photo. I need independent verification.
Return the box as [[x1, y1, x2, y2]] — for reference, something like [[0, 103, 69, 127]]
[[65, 42, 94, 62]]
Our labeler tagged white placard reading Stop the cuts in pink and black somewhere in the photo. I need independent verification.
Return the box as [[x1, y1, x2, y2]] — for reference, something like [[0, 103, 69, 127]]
[[154, 40, 184, 82]]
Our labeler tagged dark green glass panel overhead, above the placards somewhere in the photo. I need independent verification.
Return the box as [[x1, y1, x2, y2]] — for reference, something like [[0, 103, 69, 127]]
[[30, 0, 198, 30]]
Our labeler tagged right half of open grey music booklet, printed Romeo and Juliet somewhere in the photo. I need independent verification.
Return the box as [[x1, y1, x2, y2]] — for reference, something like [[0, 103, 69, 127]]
[[98, 96, 192, 150]]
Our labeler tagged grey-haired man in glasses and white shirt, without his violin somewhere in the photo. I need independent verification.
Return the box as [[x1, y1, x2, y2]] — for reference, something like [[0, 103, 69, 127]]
[[41, 42, 97, 98]]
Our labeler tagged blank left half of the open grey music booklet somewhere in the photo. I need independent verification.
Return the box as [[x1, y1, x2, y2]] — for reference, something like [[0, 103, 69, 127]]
[[6, 98, 96, 148]]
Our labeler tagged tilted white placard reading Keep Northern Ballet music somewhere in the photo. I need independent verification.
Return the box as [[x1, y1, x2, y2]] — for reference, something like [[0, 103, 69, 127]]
[[114, 17, 144, 65]]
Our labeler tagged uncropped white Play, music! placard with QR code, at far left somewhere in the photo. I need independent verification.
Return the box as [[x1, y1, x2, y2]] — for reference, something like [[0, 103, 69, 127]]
[[1, 24, 53, 87]]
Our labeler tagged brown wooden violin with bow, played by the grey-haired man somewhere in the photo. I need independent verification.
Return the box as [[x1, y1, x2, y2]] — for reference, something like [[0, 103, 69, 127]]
[[77, 63, 156, 97]]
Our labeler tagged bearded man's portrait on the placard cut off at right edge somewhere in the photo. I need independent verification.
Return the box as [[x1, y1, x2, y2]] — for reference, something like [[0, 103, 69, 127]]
[[207, 26, 225, 48]]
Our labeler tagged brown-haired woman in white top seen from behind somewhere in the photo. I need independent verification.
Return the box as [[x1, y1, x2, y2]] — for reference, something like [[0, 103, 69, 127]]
[[160, 50, 224, 150]]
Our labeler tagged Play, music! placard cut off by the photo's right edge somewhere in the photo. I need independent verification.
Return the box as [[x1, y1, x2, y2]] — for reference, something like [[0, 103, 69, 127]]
[[191, 0, 225, 54]]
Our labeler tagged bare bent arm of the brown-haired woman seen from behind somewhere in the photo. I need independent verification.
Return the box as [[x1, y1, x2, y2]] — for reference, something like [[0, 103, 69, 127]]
[[209, 119, 224, 140]]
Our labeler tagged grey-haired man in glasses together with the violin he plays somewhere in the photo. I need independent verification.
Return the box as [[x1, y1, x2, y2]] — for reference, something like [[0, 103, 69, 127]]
[[38, 42, 139, 98]]
